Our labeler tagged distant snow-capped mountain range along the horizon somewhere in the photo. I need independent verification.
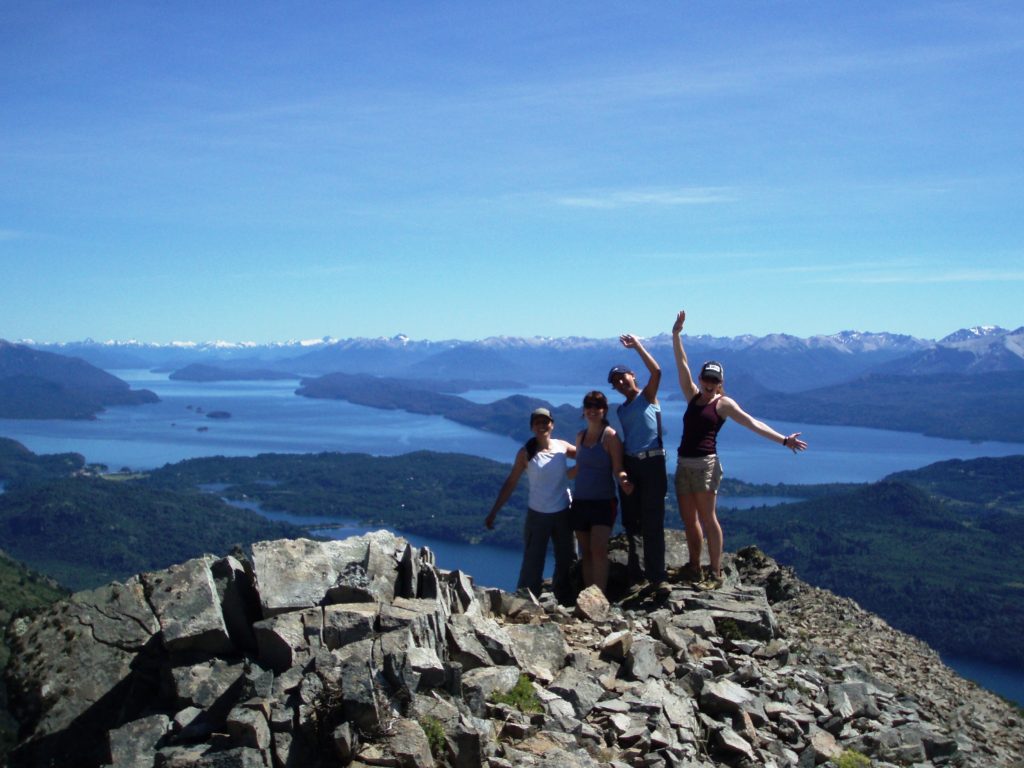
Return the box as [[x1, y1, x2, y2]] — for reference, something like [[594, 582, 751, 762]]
[[8, 326, 1024, 391]]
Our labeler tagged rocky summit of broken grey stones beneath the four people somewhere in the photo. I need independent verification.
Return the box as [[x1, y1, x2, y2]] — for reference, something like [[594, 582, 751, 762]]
[[7, 530, 1024, 768]]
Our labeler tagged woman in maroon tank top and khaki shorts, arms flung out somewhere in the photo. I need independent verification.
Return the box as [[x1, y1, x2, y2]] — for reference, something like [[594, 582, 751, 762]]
[[672, 311, 807, 586]]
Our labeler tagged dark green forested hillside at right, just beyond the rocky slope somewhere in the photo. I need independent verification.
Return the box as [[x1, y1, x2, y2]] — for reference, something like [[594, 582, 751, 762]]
[[720, 481, 1024, 666]]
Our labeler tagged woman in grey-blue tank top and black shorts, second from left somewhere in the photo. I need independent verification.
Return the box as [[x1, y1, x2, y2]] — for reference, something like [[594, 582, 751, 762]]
[[569, 390, 633, 592]]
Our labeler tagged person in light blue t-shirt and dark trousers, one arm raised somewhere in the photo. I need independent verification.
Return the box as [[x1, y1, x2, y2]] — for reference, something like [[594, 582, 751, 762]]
[[608, 334, 669, 587]]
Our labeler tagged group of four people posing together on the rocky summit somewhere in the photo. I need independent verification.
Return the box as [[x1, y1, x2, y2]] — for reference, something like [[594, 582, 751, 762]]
[[484, 311, 807, 602]]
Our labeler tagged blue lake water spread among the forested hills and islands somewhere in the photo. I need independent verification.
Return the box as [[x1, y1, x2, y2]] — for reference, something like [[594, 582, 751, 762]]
[[0, 371, 1024, 702]]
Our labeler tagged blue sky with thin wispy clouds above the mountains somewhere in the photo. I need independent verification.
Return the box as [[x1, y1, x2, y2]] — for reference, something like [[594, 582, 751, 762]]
[[0, 0, 1024, 342]]
